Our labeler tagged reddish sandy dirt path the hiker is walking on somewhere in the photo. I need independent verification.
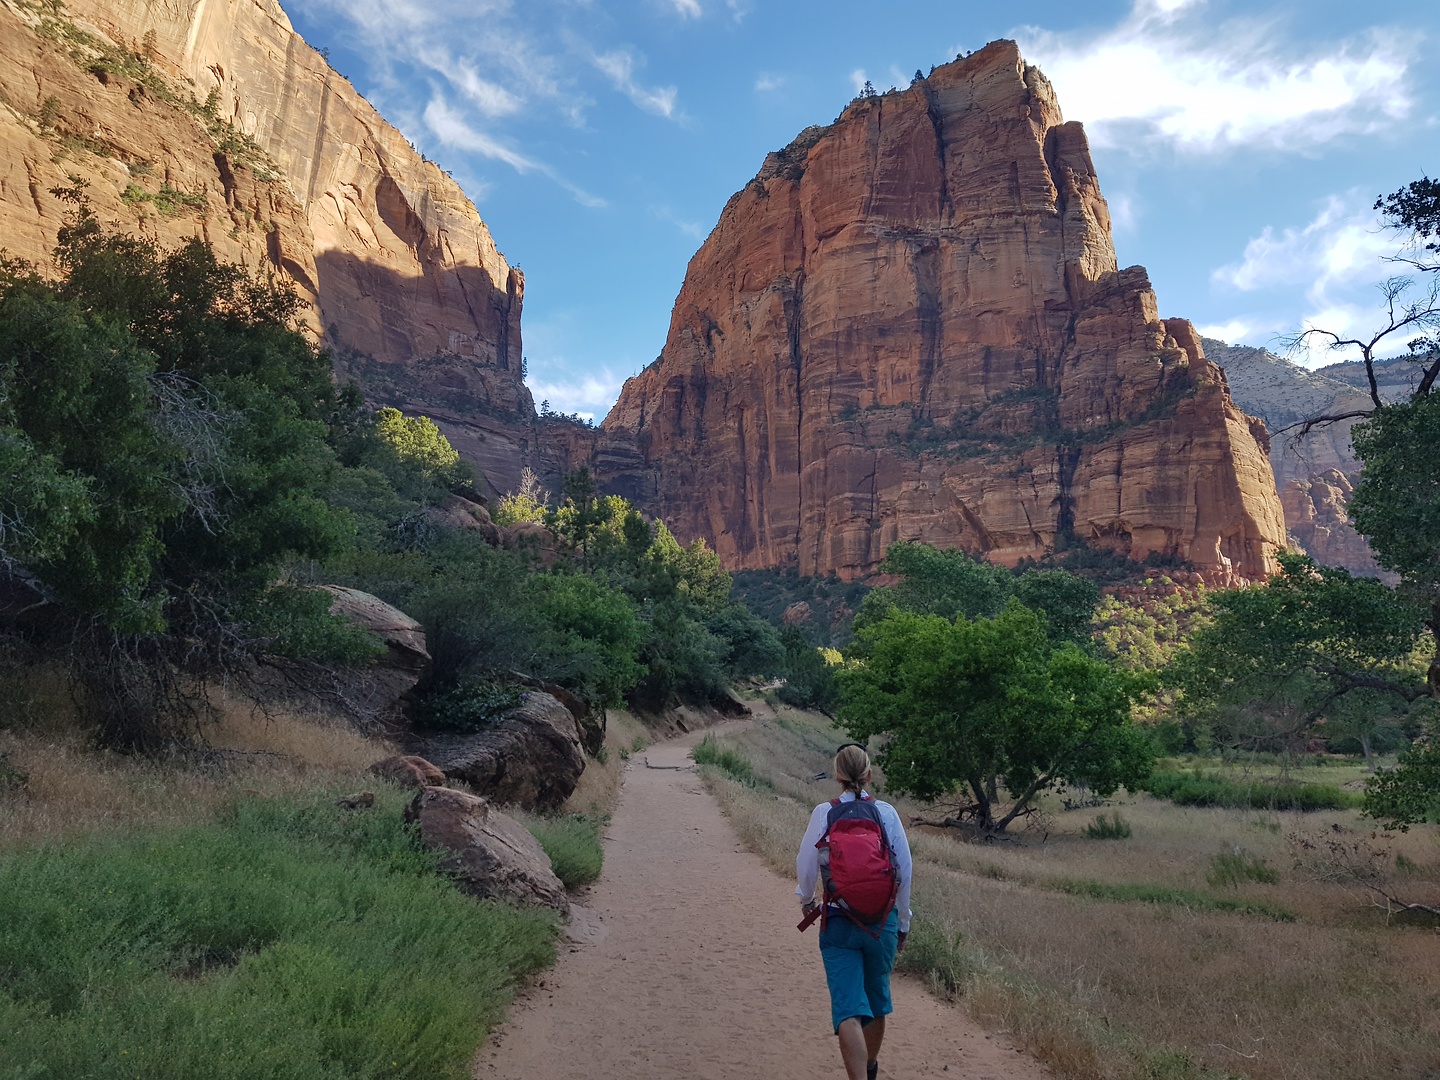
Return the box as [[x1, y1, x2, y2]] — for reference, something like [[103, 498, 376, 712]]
[[474, 729, 1048, 1080]]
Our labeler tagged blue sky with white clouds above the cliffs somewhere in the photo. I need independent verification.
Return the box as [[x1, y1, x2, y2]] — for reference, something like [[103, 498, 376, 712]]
[[282, 0, 1440, 419]]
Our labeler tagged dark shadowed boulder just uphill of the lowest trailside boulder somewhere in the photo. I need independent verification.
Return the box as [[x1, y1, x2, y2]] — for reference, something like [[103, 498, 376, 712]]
[[409, 690, 585, 809]]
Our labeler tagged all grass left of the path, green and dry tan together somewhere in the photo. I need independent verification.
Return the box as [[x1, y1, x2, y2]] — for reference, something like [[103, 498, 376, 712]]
[[0, 671, 644, 1080]]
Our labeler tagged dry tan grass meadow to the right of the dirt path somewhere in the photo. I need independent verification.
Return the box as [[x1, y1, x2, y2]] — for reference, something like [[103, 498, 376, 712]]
[[697, 710, 1440, 1080]]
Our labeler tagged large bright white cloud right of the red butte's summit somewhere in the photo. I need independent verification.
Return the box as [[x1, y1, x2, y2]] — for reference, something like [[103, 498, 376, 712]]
[[1020, 0, 1416, 153]]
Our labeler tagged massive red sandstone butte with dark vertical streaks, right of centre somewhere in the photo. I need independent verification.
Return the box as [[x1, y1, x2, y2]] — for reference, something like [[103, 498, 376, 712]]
[[595, 42, 1284, 579]]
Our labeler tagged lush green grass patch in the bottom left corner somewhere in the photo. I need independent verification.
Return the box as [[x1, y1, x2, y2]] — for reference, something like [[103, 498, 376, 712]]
[[0, 789, 554, 1080]]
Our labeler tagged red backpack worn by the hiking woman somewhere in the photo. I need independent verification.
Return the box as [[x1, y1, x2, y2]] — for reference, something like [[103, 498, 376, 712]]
[[799, 795, 900, 930]]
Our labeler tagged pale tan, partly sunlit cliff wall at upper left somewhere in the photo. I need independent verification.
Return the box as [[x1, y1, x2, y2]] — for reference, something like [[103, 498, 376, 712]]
[[0, 0, 536, 490]]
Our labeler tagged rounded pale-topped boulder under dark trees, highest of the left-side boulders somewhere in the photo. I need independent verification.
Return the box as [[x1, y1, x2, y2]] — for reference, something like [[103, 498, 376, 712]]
[[320, 585, 431, 724]]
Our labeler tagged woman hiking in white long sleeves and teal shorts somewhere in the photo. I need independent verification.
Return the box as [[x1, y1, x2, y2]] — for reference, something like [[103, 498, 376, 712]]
[[795, 743, 910, 1080]]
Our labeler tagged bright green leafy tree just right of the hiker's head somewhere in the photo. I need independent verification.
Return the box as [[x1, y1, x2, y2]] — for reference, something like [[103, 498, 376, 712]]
[[837, 600, 1153, 832]]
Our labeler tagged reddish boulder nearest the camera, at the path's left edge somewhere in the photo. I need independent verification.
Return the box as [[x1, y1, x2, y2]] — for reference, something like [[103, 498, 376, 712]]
[[405, 788, 570, 914]]
